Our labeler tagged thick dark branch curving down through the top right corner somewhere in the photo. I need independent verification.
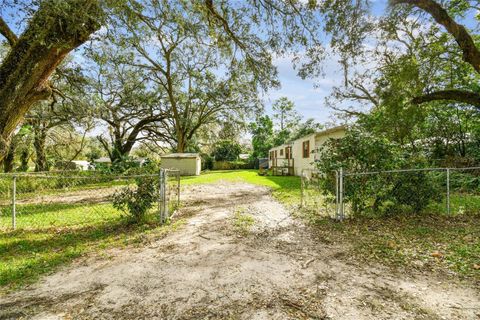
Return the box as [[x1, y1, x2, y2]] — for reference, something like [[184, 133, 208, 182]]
[[391, 0, 480, 73]]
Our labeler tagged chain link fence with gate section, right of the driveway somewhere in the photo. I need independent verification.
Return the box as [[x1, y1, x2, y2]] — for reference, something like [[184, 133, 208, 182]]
[[302, 167, 480, 220]]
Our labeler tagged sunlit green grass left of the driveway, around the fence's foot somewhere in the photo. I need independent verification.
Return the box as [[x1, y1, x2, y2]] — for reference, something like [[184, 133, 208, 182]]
[[0, 204, 183, 291]]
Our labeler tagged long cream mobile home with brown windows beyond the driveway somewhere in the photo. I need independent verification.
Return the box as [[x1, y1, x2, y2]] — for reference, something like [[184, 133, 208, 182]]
[[268, 126, 346, 176]]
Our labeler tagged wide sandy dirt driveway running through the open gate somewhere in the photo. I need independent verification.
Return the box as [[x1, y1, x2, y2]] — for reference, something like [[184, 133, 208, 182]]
[[0, 183, 480, 319]]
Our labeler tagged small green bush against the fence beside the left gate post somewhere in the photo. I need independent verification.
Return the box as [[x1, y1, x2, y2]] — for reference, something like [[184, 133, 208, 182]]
[[113, 177, 158, 223]]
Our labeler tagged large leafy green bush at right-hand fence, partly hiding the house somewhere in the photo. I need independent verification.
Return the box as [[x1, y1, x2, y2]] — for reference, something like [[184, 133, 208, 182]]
[[316, 130, 441, 215]]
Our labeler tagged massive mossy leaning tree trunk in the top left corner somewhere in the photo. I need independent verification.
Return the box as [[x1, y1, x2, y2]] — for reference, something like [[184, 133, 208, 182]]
[[0, 0, 101, 160]]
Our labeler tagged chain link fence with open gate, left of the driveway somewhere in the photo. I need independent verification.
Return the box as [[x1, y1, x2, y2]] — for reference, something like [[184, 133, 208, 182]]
[[0, 169, 180, 229]]
